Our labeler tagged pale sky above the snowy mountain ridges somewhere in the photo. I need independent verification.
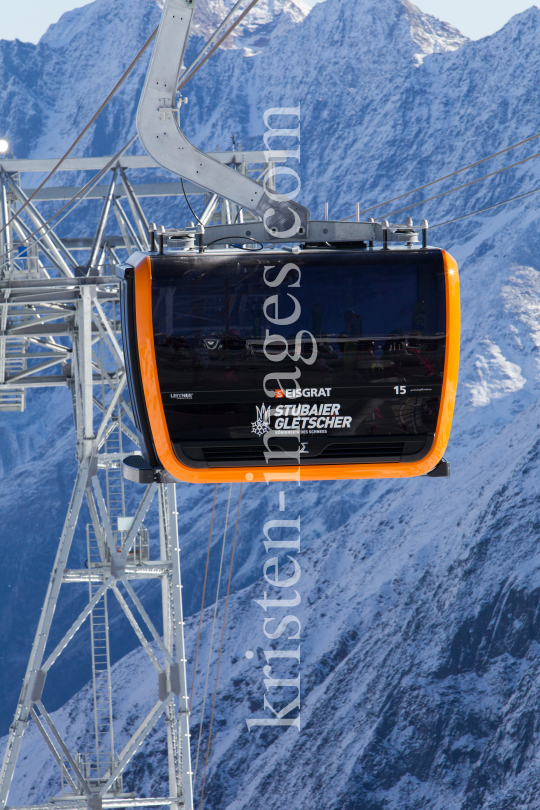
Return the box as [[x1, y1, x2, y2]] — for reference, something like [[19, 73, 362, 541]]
[[0, 0, 540, 42]]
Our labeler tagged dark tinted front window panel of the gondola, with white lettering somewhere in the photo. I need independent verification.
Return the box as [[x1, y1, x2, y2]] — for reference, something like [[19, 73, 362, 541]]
[[152, 250, 446, 463]]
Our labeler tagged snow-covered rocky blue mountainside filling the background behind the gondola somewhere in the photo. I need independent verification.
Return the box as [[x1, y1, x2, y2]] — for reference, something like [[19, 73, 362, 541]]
[[5, 0, 540, 810]]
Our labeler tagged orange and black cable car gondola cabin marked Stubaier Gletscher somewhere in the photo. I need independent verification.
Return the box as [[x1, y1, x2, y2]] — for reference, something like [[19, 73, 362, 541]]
[[120, 223, 460, 483]]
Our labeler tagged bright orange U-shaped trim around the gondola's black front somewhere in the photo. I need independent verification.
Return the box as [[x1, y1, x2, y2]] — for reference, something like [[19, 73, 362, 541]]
[[135, 250, 461, 484]]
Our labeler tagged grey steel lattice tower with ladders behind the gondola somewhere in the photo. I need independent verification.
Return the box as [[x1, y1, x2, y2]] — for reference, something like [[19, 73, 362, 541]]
[[0, 151, 286, 810]]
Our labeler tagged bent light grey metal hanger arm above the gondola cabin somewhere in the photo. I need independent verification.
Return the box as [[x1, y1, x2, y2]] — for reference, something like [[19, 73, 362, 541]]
[[137, 0, 310, 241]]
